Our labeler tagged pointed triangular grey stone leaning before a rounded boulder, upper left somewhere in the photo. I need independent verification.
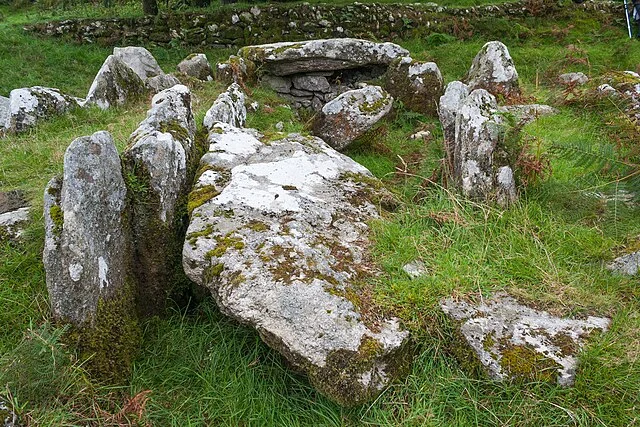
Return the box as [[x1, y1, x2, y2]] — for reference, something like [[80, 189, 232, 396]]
[[84, 55, 146, 110]]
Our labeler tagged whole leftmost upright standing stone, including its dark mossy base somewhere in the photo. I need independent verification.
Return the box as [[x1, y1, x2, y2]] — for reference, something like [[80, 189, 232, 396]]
[[44, 132, 139, 378]]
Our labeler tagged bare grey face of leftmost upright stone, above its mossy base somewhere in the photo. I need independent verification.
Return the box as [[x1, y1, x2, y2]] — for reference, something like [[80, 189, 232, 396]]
[[44, 132, 127, 326]]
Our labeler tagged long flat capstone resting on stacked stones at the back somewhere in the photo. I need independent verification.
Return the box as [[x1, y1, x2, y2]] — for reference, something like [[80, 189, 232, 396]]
[[238, 38, 409, 76]]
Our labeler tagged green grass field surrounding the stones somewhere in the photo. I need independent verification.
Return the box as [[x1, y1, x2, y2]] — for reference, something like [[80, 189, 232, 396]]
[[0, 0, 640, 426]]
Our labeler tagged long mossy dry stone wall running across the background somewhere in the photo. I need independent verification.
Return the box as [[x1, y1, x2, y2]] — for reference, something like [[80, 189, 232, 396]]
[[26, 1, 620, 47]]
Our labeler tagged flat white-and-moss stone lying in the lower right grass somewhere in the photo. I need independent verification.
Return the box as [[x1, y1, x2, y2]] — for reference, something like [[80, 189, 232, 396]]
[[441, 294, 610, 386]]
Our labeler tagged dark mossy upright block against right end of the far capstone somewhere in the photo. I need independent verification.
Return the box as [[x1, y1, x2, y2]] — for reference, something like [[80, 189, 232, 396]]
[[385, 56, 444, 115]]
